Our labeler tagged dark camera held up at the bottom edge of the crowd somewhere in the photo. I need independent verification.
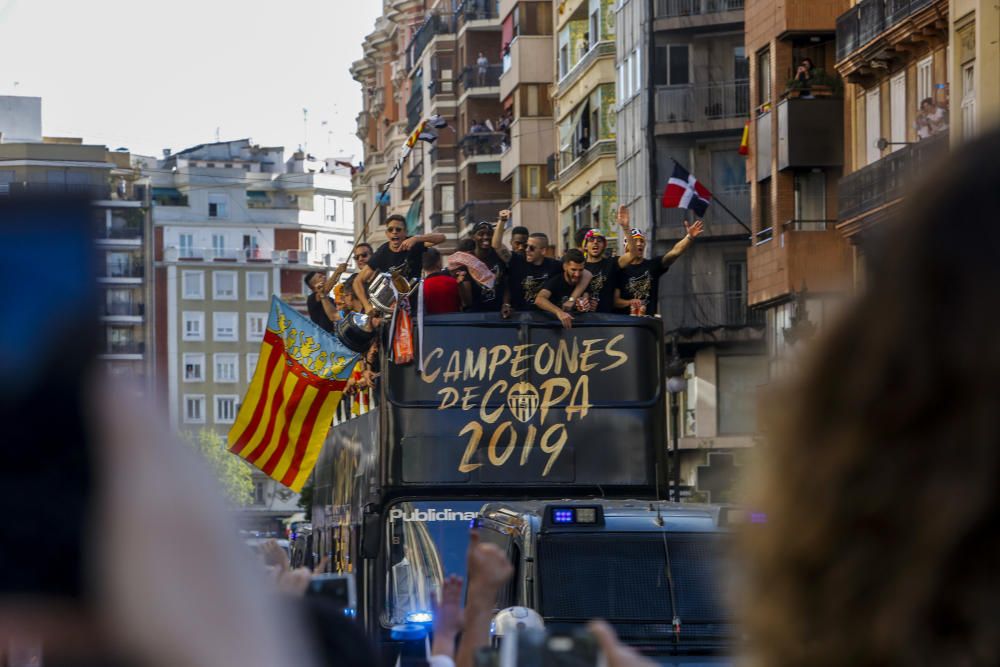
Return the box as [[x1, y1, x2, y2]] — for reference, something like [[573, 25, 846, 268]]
[[500, 628, 607, 667]]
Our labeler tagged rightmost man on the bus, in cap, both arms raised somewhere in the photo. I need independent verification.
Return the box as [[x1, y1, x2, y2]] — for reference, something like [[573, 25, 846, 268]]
[[615, 214, 705, 315]]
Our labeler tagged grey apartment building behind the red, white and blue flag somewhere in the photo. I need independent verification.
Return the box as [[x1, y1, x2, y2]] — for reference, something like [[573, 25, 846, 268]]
[[615, 0, 767, 496]]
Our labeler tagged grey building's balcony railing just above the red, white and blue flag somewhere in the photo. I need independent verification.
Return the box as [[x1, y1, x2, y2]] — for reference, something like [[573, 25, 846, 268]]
[[656, 79, 750, 123]]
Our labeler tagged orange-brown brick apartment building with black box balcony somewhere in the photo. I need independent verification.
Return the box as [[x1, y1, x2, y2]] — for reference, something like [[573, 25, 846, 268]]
[[745, 0, 856, 378]]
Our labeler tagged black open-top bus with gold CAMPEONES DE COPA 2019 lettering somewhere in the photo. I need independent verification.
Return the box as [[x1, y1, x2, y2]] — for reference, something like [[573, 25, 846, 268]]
[[312, 313, 666, 640]]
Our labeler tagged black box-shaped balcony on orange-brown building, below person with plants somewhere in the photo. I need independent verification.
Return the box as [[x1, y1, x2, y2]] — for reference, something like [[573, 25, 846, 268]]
[[768, 98, 844, 170]]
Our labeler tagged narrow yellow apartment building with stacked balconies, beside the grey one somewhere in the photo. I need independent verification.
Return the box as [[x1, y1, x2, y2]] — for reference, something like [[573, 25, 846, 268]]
[[548, 0, 619, 252]]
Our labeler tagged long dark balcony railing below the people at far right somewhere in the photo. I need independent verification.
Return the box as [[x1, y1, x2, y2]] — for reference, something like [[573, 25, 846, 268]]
[[838, 132, 948, 221]]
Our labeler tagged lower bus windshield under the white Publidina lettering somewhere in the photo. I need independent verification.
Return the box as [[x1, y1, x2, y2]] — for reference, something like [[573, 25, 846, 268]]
[[382, 499, 490, 627]]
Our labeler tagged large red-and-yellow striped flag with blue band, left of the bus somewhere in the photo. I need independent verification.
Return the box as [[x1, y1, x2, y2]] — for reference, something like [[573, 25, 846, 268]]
[[228, 297, 358, 491]]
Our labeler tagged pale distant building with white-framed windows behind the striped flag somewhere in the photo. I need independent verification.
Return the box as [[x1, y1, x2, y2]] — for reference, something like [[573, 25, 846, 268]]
[[146, 139, 354, 529]]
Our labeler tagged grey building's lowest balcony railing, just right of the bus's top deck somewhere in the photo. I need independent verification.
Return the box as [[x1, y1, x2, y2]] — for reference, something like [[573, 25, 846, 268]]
[[660, 291, 764, 331]]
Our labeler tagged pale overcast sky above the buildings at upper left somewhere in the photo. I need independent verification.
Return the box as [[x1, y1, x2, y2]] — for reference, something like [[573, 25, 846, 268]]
[[0, 0, 382, 161]]
